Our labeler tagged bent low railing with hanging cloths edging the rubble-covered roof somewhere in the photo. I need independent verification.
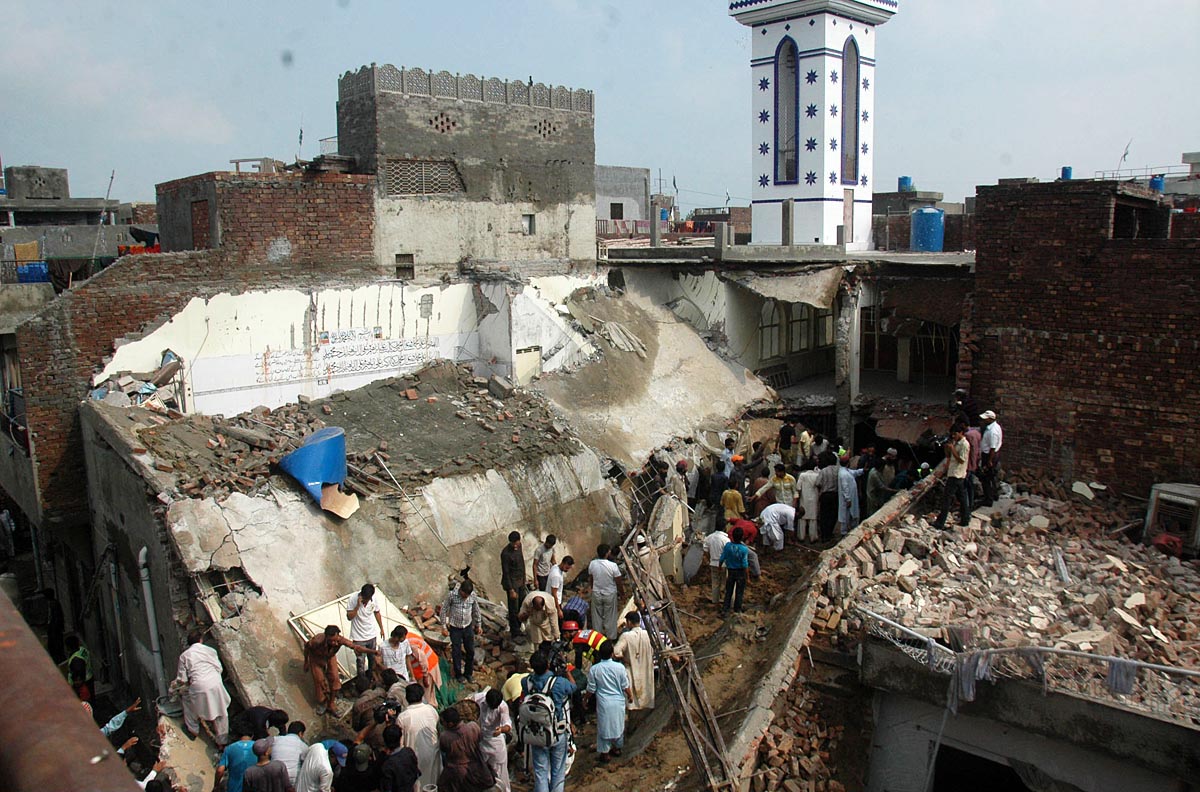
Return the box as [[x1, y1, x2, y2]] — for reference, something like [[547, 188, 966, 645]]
[[856, 606, 1200, 728]]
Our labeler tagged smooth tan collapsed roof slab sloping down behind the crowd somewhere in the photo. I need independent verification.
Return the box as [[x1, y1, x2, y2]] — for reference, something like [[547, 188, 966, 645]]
[[533, 292, 770, 466]]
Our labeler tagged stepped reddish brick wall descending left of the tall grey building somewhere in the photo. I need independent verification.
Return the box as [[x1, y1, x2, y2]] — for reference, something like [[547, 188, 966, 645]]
[[17, 174, 379, 526]]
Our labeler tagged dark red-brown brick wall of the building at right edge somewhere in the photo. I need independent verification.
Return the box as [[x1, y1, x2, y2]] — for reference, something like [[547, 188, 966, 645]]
[[970, 181, 1200, 493]]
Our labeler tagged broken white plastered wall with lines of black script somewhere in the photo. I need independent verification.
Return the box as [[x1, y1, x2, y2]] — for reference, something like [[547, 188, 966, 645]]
[[95, 277, 594, 415]]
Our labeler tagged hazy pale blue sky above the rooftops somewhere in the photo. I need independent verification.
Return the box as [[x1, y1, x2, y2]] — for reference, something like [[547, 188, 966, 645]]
[[0, 0, 1200, 209]]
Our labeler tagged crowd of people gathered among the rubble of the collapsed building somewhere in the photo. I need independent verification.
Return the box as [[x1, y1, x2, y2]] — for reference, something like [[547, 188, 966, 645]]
[[75, 392, 1003, 792]]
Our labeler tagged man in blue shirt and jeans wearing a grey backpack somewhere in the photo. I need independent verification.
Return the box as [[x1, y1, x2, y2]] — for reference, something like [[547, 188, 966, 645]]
[[518, 652, 576, 792]]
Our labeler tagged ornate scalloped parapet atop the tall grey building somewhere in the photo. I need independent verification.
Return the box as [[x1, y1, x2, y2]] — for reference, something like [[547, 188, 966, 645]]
[[337, 64, 595, 114]]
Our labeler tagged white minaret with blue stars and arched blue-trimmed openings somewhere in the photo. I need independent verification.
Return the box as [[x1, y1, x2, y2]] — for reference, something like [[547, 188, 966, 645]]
[[730, 0, 899, 250]]
